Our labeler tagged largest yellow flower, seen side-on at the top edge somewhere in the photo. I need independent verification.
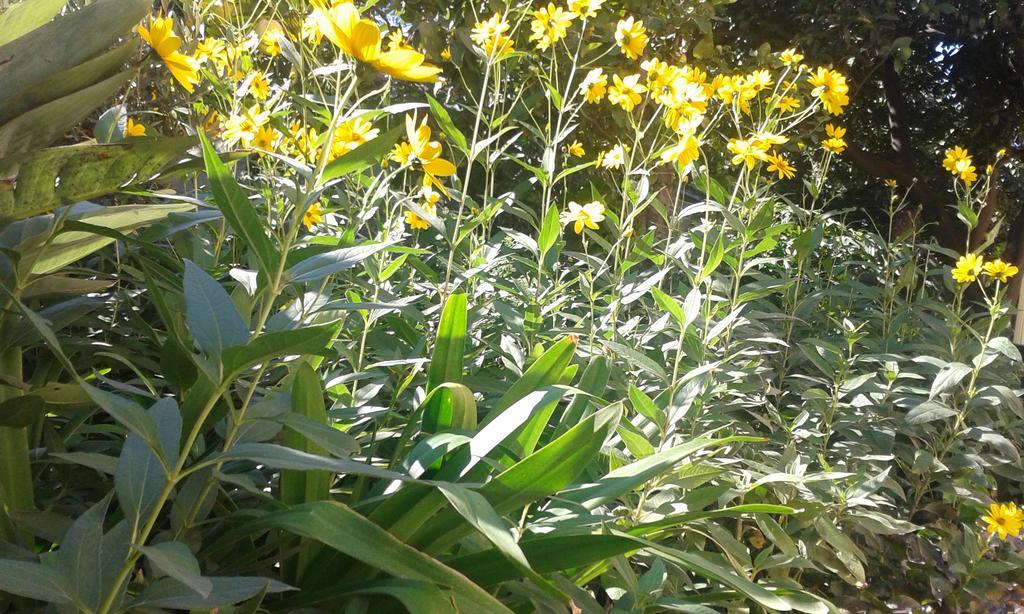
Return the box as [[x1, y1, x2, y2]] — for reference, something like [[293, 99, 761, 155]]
[[317, 2, 441, 83]]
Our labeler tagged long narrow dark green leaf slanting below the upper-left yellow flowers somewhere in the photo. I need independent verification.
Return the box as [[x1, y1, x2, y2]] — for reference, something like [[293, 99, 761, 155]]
[[199, 130, 281, 279]]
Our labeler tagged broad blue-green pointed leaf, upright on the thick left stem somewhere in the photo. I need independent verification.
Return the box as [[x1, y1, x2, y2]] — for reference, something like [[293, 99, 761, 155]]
[[184, 260, 249, 360]]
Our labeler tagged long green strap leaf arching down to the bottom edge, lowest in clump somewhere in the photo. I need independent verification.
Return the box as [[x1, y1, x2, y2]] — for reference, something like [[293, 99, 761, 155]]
[[258, 501, 511, 612]]
